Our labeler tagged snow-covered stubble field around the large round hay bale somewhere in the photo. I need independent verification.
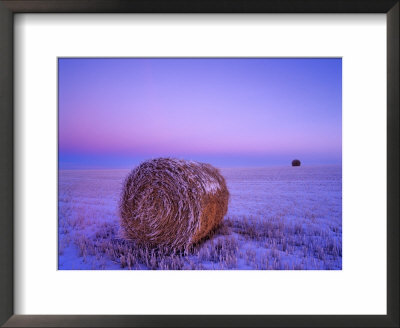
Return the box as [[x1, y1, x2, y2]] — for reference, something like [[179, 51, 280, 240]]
[[58, 166, 342, 270]]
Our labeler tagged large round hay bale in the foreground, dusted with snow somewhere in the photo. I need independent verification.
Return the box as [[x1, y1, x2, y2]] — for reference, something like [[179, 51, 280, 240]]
[[119, 158, 229, 248]]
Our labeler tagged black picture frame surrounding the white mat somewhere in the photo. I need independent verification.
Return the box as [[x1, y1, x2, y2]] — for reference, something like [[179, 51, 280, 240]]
[[0, 0, 400, 327]]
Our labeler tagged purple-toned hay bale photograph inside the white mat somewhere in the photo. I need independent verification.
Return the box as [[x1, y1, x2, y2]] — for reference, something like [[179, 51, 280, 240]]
[[58, 57, 342, 270]]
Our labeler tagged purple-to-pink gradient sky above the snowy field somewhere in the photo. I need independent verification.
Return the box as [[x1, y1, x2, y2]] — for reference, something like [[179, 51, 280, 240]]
[[58, 58, 342, 169]]
